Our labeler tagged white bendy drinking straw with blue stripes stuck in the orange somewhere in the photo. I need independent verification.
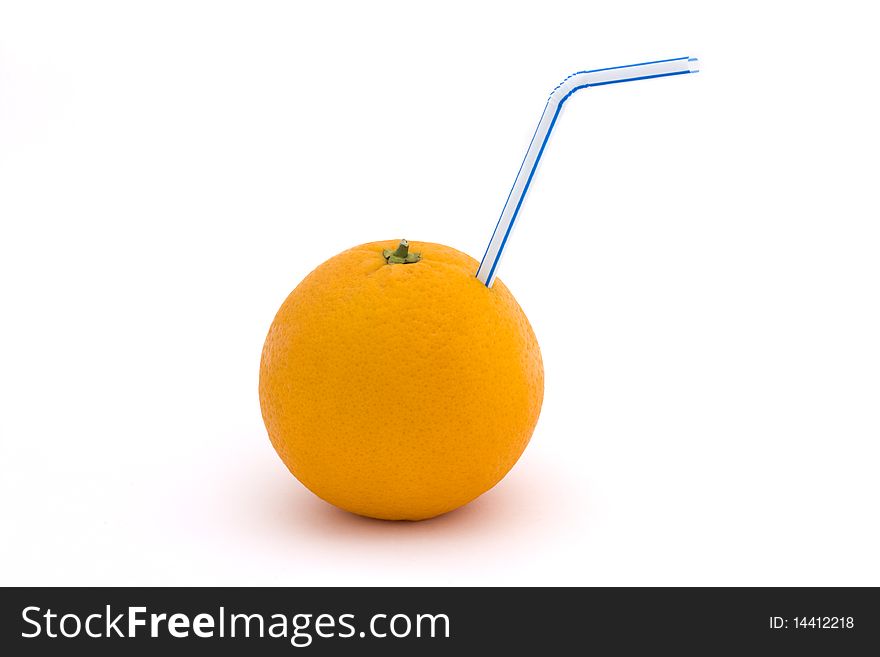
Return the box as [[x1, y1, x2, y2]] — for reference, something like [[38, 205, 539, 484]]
[[477, 57, 700, 287]]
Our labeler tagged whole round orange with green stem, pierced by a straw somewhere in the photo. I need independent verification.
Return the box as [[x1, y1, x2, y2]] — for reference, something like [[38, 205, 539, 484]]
[[260, 241, 544, 520]]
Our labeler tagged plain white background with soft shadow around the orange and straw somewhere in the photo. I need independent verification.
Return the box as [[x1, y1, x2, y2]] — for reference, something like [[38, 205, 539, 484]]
[[0, 2, 880, 585]]
